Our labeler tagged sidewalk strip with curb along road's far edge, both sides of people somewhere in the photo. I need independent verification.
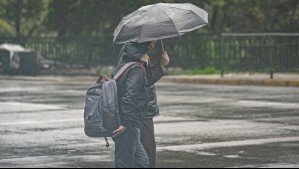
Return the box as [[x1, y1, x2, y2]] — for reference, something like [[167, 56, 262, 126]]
[[0, 73, 299, 87]]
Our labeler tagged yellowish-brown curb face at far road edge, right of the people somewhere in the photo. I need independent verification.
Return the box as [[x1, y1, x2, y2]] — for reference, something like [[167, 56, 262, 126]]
[[162, 77, 299, 87]]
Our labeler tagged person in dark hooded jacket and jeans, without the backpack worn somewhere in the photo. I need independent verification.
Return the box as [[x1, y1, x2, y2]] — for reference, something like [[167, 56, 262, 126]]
[[112, 43, 149, 168]]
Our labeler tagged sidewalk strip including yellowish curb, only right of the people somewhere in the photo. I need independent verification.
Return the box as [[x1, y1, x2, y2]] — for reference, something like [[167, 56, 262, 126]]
[[162, 73, 299, 87]]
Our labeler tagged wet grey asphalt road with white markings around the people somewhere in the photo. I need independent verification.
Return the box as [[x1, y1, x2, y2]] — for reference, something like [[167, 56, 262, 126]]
[[0, 77, 299, 168]]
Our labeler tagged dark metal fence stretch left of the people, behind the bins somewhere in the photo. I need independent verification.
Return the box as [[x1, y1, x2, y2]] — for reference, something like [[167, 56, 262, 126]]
[[0, 37, 120, 67]]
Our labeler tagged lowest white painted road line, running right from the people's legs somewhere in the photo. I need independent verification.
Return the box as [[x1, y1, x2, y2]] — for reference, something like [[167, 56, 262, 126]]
[[157, 137, 299, 151]]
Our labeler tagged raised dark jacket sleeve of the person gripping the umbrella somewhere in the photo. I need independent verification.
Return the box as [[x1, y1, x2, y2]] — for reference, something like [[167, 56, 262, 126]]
[[148, 63, 167, 86]]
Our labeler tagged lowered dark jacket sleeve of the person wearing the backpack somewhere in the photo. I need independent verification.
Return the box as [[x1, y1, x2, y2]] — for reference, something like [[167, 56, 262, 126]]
[[121, 66, 145, 127]]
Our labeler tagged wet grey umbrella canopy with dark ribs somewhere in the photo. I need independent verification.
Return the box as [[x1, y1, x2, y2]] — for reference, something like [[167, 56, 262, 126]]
[[113, 3, 208, 44]]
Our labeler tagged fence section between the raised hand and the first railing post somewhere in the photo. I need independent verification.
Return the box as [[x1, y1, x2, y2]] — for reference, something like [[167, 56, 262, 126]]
[[164, 34, 221, 69]]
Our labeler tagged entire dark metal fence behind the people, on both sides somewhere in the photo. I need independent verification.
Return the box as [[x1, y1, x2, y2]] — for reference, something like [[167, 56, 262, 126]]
[[0, 33, 299, 74]]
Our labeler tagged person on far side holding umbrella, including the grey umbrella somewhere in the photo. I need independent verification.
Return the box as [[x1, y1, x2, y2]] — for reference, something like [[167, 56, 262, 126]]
[[113, 3, 208, 167]]
